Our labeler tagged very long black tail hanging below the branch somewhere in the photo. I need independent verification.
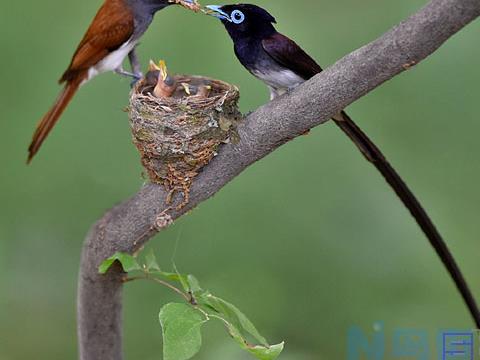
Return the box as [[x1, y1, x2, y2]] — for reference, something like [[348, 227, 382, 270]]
[[333, 111, 480, 328]]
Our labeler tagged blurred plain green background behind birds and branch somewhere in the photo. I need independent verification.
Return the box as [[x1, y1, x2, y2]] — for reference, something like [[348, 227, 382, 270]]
[[0, 0, 480, 360]]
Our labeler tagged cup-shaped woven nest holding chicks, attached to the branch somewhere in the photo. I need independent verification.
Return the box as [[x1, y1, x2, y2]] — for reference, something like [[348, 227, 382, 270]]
[[129, 75, 242, 208]]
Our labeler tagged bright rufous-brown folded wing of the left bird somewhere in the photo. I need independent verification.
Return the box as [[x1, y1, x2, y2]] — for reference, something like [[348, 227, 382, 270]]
[[60, 0, 134, 83]]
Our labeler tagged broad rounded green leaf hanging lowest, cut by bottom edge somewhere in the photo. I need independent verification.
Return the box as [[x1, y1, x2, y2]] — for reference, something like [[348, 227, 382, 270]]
[[159, 303, 207, 360]]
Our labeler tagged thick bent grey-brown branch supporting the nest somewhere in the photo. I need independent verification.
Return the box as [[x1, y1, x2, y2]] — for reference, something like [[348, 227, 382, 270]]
[[78, 0, 480, 360]]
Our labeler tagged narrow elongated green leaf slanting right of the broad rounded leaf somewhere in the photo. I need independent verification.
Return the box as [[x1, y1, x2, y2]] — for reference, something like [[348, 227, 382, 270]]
[[197, 292, 268, 346]]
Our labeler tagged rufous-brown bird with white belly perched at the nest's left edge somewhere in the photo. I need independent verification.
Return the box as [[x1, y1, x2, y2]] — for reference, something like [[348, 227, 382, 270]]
[[27, 0, 200, 163]]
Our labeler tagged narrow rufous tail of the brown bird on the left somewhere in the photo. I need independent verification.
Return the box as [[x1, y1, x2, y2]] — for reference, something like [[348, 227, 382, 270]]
[[27, 79, 81, 163]]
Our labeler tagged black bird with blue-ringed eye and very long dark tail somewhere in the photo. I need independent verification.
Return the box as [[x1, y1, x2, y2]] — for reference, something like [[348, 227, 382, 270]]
[[204, 4, 480, 328]]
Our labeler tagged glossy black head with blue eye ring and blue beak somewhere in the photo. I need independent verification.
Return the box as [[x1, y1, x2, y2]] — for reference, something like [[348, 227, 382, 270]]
[[207, 4, 276, 39]]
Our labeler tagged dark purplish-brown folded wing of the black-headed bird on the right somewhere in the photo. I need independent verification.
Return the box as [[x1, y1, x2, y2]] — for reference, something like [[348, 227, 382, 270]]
[[262, 33, 322, 80]]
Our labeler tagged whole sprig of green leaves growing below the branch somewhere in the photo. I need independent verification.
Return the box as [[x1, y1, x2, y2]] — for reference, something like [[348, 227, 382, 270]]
[[99, 252, 284, 360]]
